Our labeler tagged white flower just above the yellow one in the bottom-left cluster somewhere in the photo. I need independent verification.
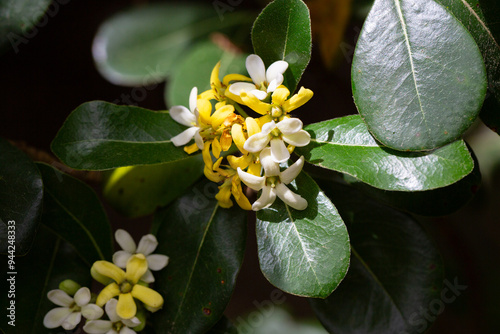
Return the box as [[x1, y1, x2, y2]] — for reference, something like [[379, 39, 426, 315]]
[[113, 229, 168, 283]]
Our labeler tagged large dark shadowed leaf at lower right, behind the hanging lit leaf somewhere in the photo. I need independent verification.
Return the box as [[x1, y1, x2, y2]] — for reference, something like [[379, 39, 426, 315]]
[[310, 184, 444, 334]]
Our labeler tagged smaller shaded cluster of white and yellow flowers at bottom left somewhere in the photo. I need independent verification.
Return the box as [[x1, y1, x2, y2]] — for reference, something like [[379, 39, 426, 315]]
[[43, 229, 168, 334]]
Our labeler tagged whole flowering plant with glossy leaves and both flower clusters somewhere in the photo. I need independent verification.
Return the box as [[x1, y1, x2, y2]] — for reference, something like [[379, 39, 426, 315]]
[[0, 0, 500, 334]]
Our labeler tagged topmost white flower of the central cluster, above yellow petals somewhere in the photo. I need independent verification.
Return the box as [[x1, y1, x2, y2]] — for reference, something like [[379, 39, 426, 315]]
[[229, 55, 288, 100]]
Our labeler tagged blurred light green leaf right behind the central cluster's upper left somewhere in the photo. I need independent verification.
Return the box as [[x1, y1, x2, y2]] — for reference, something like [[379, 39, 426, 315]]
[[165, 42, 246, 106]]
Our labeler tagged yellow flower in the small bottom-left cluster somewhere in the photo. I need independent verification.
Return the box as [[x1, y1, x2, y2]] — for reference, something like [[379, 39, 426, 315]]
[[90, 254, 163, 319]]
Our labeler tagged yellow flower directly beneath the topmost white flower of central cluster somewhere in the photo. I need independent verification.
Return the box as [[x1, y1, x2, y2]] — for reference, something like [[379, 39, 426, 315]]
[[240, 86, 313, 121]]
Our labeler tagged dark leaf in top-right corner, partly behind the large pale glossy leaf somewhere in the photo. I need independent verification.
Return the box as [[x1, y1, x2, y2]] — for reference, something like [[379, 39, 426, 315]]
[[437, 0, 500, 133]]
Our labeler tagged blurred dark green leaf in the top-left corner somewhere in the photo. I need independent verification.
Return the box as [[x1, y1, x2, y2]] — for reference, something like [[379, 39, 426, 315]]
[[0, 0, 52, 53]]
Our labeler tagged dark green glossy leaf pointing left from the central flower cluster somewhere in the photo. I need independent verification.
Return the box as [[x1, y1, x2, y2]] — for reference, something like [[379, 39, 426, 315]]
[[51, 101, 189, 170]]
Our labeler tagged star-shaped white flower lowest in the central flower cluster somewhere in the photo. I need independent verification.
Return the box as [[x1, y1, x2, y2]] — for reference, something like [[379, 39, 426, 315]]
[[238, 147, 307, 211]]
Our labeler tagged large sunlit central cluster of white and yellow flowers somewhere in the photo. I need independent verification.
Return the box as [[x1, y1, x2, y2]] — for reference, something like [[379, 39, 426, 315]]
[[170, 55, 313, 211]]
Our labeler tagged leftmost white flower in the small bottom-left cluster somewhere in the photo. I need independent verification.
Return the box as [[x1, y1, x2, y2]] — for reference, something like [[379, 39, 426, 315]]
[[43, 287, 104, 330]]
